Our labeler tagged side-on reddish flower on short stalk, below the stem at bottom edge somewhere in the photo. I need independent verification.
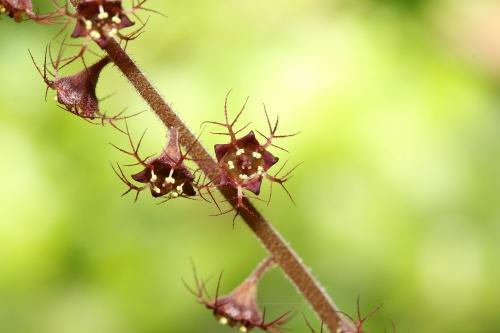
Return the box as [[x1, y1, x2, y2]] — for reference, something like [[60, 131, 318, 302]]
[[186, 258, 290, 332]]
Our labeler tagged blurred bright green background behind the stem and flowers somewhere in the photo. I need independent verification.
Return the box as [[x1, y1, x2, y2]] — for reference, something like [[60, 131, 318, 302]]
[[0, 0, 500, 333]]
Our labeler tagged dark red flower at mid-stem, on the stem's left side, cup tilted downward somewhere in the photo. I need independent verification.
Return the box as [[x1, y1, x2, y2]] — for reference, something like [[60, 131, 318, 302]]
[[115, 126, 196, 199]]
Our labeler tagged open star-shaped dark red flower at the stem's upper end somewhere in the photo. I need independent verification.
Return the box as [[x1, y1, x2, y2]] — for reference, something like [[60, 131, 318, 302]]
[[71, 0, 134, 48]]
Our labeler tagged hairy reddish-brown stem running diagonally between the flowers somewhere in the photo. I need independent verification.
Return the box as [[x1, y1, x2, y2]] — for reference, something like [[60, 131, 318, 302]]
[[105, 40, 352, 332]]
